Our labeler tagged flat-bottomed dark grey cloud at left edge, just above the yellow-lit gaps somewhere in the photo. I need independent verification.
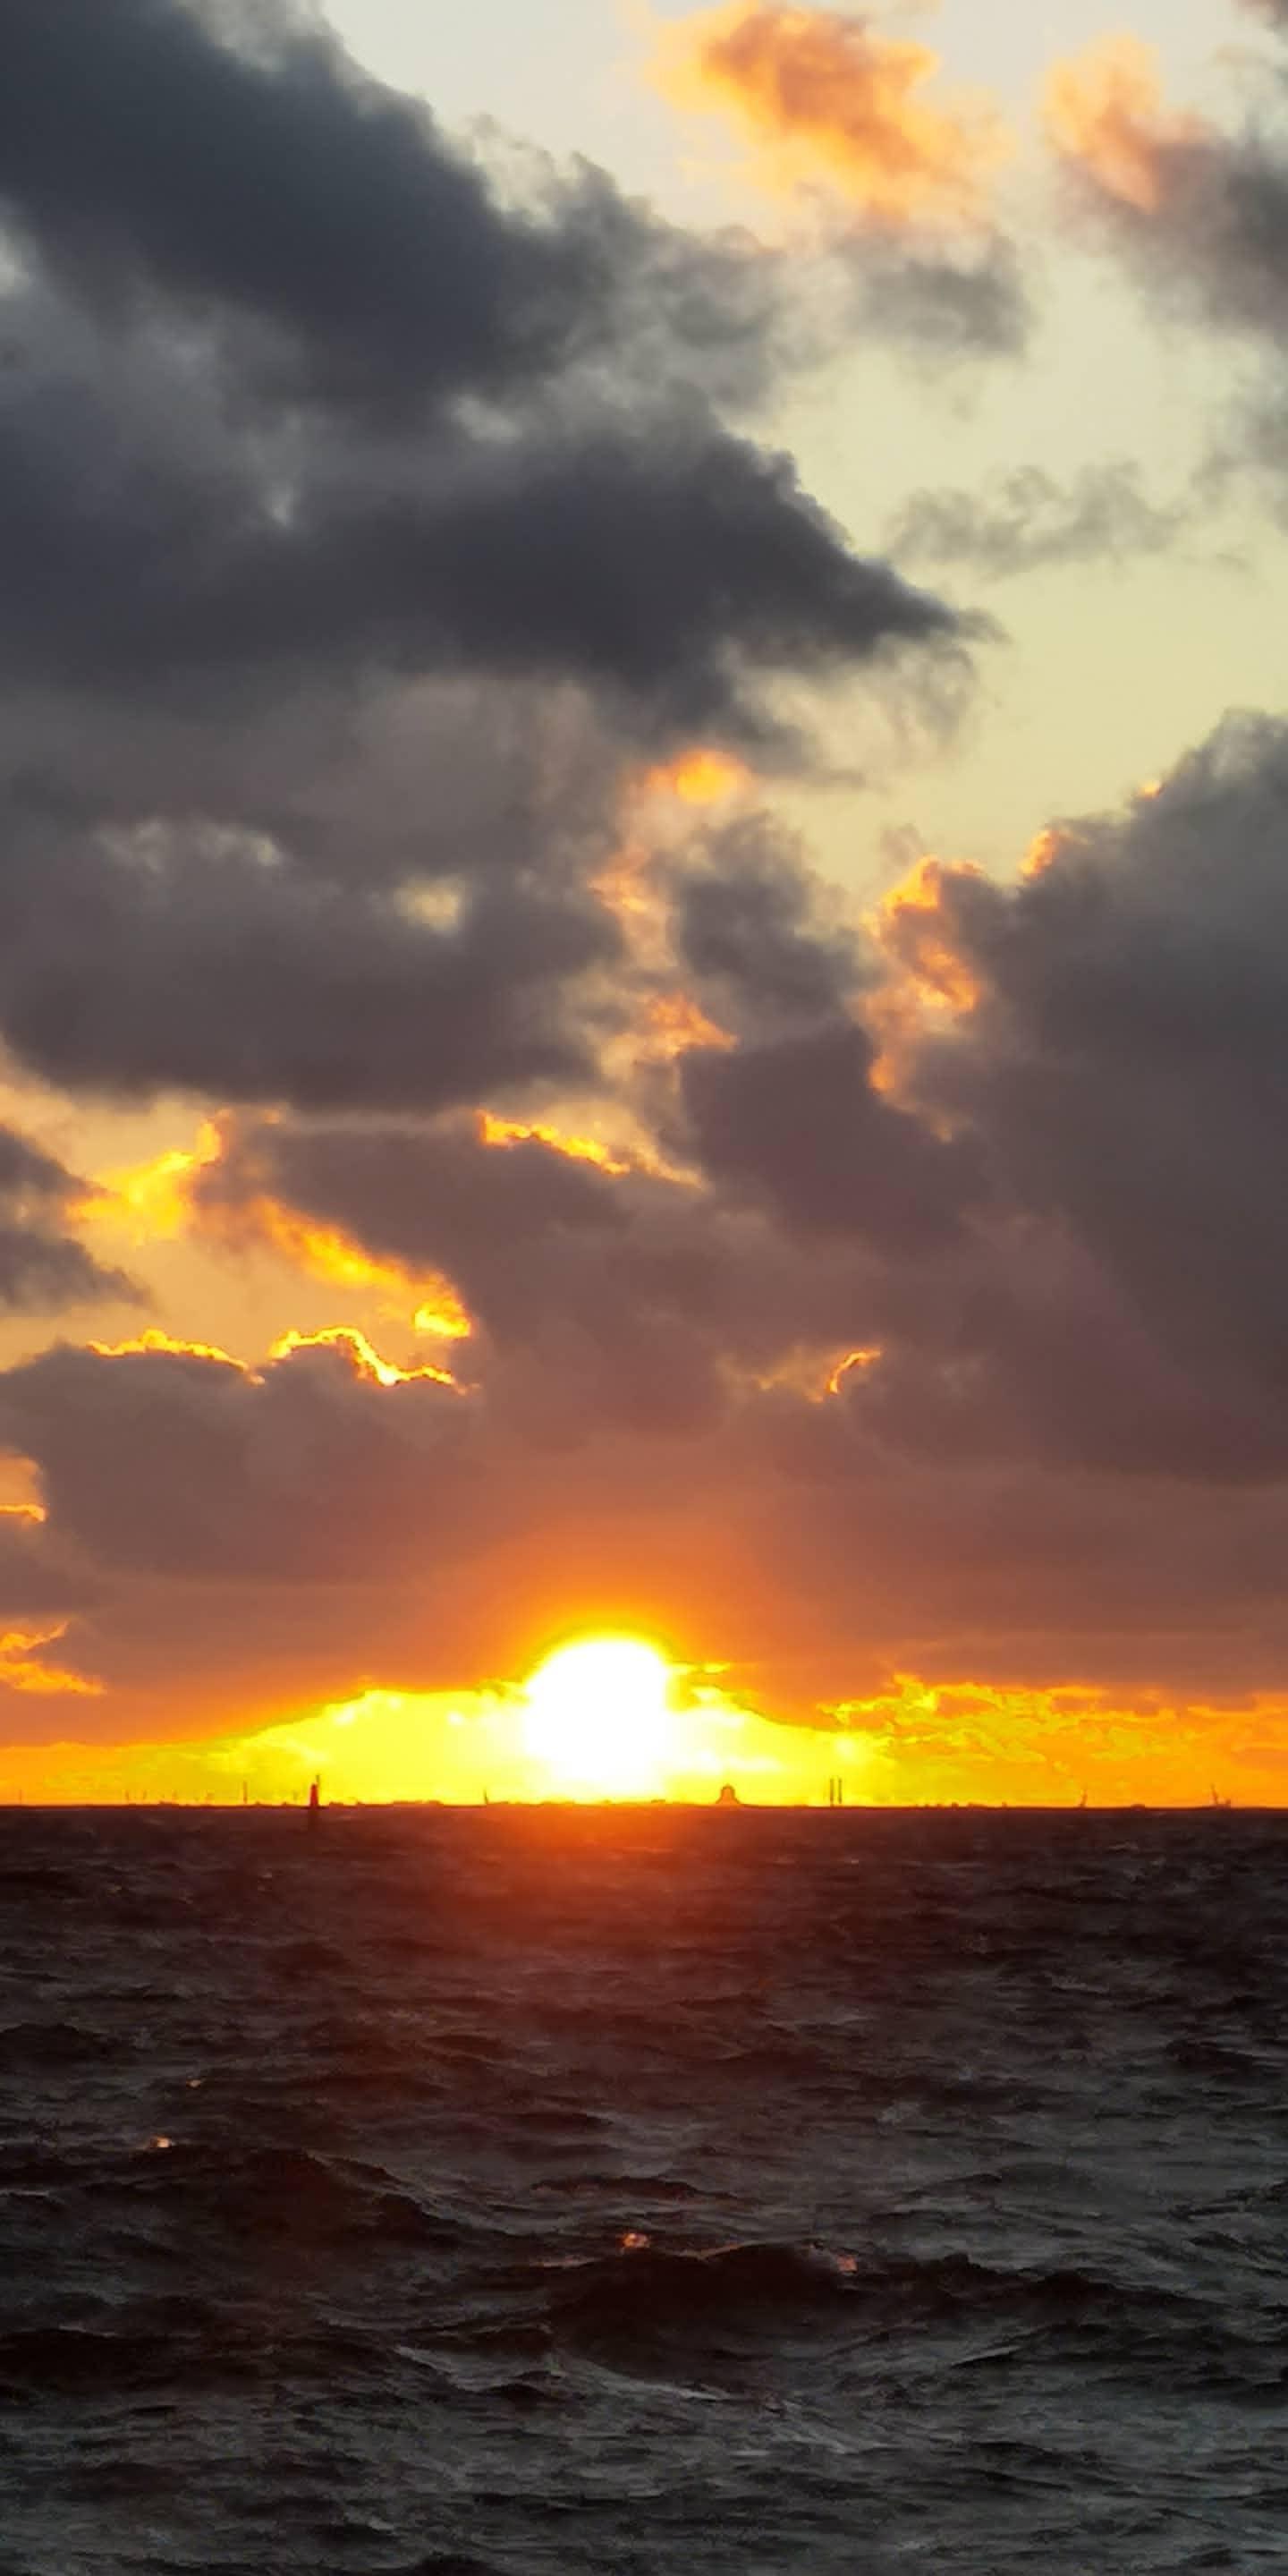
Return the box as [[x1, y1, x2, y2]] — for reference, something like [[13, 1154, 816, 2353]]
[[0, 801, 618, 1108]]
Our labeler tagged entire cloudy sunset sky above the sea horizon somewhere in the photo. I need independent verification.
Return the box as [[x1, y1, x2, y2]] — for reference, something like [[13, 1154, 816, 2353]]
[[0, 0, 1288, 1803]]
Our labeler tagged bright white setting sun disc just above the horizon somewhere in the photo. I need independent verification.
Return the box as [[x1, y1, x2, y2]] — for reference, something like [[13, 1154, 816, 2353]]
[[523, 1636, 673, 1798]]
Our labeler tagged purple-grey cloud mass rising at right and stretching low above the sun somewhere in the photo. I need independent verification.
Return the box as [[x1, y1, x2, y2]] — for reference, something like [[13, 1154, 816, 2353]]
[[0, 724, 1288, 1708]]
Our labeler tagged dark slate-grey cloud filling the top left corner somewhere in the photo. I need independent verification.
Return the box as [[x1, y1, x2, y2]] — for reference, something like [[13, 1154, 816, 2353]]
[[0, 0, 765, 404]]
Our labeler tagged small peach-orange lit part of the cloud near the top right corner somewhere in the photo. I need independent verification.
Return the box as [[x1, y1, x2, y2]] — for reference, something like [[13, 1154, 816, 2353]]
[[1043, 36, 1206, 214]]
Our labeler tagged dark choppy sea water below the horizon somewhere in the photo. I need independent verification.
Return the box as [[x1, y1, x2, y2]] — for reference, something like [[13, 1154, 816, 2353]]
[[0, 1811, 1288, 2576]]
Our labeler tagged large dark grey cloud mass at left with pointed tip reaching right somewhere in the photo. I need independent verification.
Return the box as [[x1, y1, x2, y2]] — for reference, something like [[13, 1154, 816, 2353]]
[[0, 251, 955, 1128]]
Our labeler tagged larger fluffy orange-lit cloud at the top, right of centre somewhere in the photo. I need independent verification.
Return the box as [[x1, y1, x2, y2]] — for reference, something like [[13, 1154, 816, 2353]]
[[655, 0, 1007, 226]]
